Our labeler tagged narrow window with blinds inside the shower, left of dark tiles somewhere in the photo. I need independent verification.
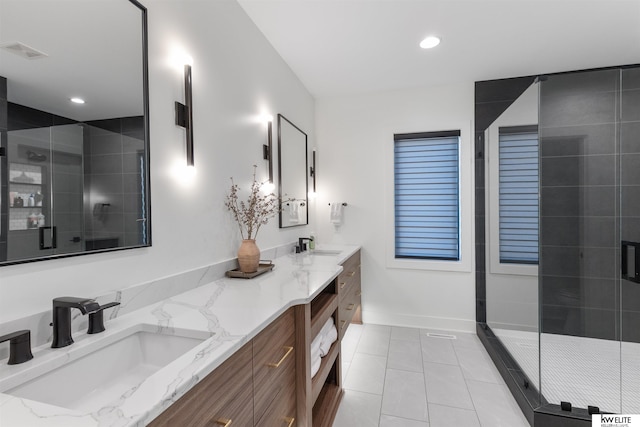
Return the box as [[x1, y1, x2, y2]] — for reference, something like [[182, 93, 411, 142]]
[[499, 126, 539, 264]]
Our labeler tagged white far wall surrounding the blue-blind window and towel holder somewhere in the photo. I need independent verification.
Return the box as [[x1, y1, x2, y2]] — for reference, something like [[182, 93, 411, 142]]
[[316, 82, 475, 331]]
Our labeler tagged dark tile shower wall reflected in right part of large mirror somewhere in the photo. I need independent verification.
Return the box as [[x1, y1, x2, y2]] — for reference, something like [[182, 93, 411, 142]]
[[85, 116, 144, 248]]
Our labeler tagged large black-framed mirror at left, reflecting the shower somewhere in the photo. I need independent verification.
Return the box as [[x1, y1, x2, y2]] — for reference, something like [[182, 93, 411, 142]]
[[0, 0, 151, 265]]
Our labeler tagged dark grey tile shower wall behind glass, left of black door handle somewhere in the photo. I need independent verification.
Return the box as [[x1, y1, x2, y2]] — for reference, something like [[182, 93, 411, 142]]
[[539, 70, 620, 340]]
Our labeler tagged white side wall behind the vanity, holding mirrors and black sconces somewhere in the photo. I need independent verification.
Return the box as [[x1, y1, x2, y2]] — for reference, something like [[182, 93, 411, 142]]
[[0, 0, 315, 323]]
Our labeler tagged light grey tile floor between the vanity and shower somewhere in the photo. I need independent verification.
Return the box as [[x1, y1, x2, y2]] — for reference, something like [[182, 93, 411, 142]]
[[333, 325, 529, 427]]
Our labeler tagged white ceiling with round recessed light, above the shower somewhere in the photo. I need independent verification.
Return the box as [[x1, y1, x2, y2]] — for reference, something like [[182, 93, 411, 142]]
[[239, 0, 640, 98]]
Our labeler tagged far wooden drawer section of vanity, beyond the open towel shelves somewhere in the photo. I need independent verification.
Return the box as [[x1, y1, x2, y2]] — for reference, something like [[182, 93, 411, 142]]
[[336, 251, 362, 339]]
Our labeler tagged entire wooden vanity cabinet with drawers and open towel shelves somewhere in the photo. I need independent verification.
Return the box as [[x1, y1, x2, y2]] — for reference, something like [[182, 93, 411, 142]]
[[150, 251, 361, 427]]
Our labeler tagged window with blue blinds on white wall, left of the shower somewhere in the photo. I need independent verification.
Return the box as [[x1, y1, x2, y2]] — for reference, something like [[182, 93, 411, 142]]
[[394, 131, 460, 261]]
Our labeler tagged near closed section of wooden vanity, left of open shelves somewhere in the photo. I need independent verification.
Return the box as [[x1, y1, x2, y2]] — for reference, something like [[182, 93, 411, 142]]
[[149, 309, 296, 427]]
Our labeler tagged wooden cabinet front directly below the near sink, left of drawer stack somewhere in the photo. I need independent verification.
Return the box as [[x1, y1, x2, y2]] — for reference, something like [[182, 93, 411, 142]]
[[149, 343, 253, 427]]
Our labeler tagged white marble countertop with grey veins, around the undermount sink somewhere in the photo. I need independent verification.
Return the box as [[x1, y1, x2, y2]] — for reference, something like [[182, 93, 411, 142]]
[[0, 245, 359, 427]]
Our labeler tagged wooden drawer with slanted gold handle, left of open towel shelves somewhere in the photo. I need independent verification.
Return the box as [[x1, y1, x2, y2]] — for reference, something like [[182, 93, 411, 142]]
[[253, 309, 296, 420]]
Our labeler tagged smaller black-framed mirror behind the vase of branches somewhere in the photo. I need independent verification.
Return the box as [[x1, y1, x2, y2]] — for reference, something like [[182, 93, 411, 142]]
[[278, 114, 309, 228]]
